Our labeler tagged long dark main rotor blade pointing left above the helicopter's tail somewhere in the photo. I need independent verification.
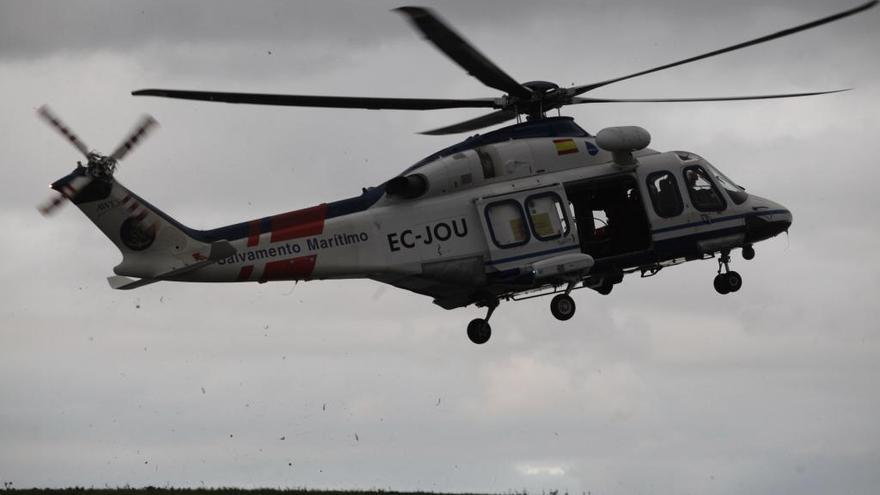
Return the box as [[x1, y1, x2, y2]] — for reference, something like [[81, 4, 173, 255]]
[[131, 89, 500, 110]]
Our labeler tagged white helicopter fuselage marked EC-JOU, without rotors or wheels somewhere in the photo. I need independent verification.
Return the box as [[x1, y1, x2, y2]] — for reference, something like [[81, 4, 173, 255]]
[[72, 118, 791, 308]]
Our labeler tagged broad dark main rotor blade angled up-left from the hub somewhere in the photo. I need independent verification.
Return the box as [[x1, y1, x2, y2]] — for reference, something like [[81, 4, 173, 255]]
[[394, 7, 532, 99]]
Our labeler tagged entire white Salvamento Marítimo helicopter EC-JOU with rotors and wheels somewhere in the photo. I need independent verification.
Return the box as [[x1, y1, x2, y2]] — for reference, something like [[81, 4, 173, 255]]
[[38, 0, 878, 344]]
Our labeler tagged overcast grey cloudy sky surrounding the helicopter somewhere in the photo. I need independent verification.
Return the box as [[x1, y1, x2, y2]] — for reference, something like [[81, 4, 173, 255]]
[[0, 0, 880, 494]]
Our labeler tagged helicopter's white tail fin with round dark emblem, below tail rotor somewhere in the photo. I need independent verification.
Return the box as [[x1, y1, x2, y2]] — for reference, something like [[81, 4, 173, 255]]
[[52, 167, 218, 278]]
